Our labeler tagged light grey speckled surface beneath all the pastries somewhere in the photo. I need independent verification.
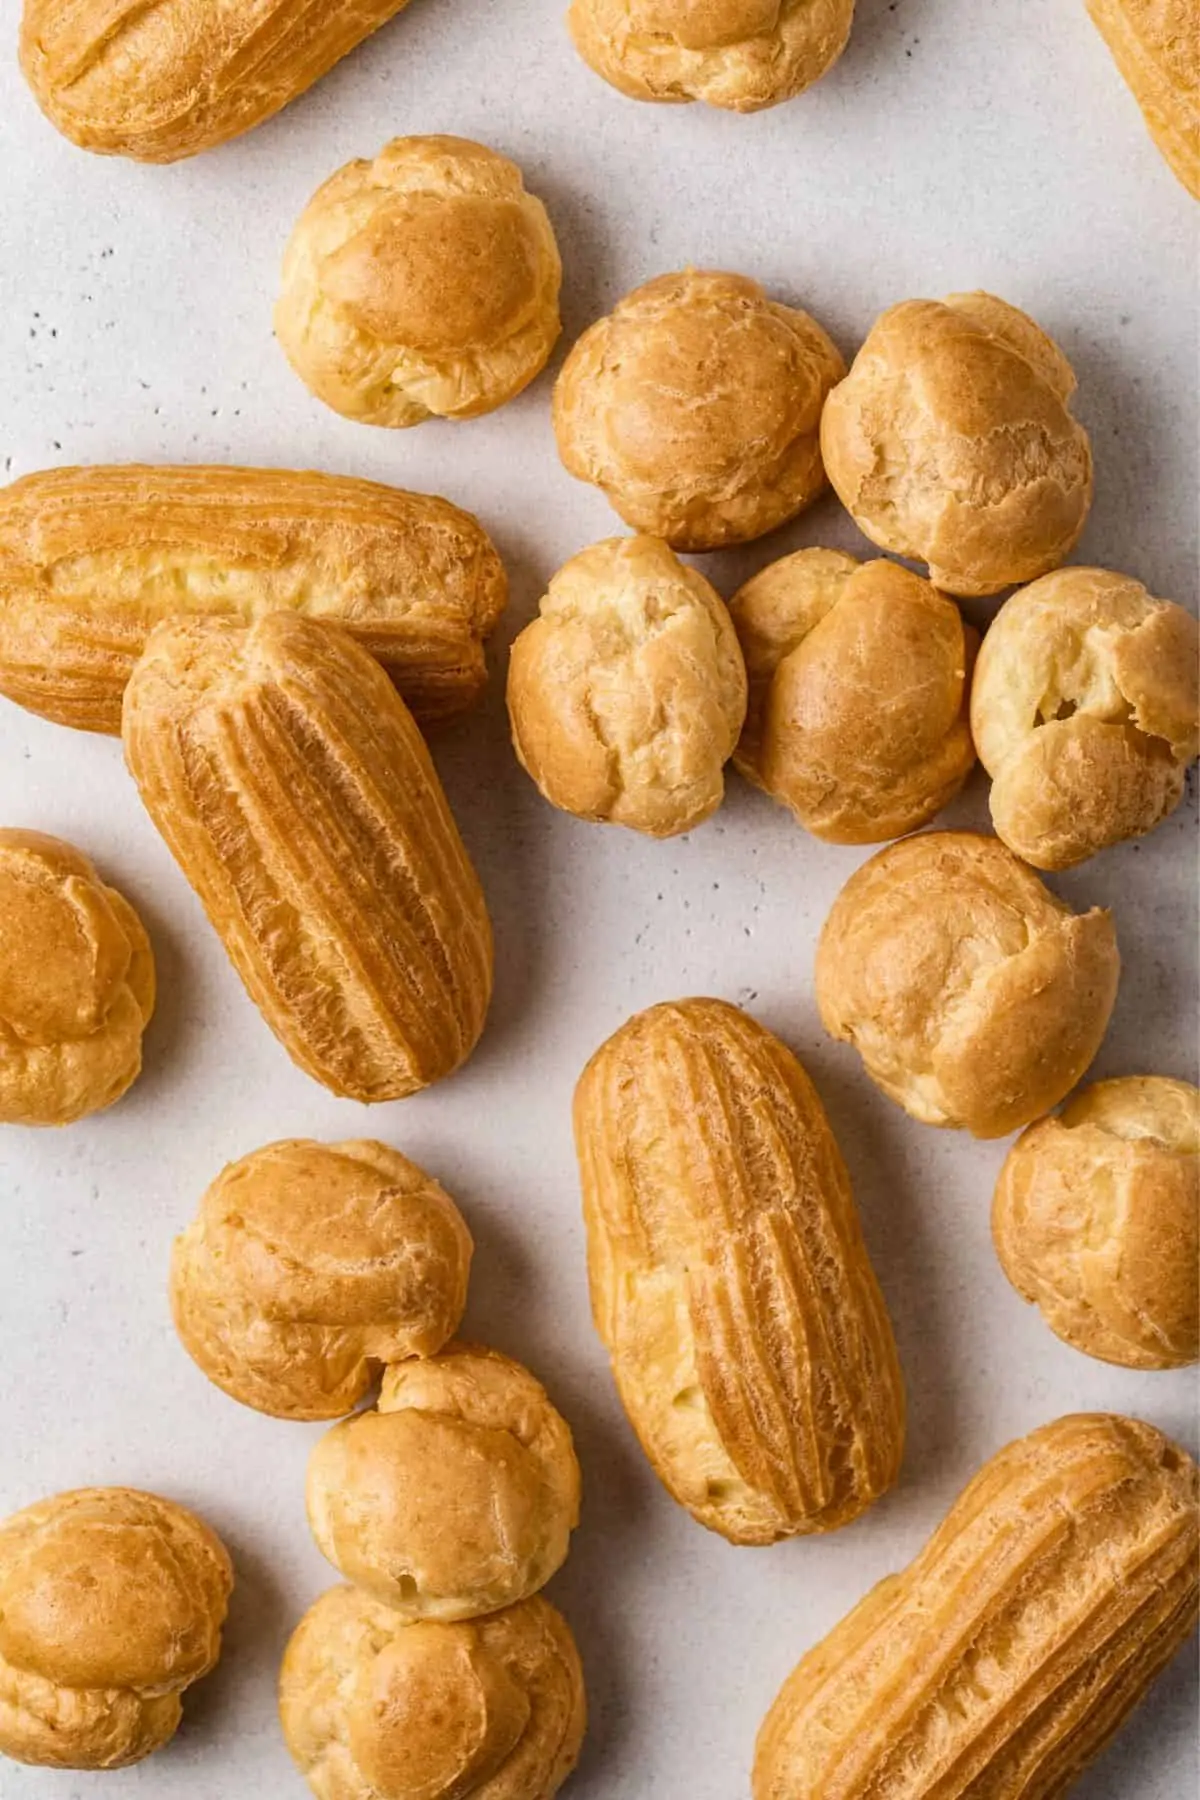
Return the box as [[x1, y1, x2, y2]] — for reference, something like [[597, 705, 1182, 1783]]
[[0, 0, 1200, 1800]]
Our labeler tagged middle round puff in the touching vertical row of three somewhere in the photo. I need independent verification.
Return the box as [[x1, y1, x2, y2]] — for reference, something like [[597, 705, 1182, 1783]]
[[308, 1345, 579, 1620]]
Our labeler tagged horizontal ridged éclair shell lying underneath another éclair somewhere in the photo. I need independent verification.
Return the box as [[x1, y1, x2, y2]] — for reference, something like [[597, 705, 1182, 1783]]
[[0, 466, 507, 733]]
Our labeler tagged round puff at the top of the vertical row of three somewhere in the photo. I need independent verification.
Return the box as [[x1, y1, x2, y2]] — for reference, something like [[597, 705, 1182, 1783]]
[[171, 1139, 471, 1418]]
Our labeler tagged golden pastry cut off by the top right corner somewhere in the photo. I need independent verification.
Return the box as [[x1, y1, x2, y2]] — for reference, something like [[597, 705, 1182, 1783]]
[[1087, 0, 1200, 200]]
